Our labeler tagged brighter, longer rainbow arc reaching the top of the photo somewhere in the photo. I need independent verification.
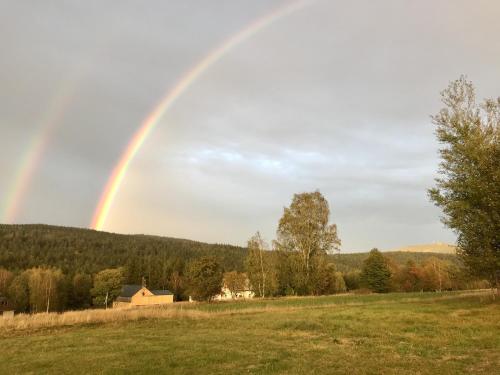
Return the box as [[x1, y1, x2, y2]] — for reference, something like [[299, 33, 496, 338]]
[[90, 0, 314, 230]]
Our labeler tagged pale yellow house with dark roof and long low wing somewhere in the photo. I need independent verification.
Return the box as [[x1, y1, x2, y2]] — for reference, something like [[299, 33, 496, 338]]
[[113, 285, 174, 308]]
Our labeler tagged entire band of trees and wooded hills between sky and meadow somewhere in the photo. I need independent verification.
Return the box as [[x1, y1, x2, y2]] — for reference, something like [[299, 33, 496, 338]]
[[0, 77, 500, 312]]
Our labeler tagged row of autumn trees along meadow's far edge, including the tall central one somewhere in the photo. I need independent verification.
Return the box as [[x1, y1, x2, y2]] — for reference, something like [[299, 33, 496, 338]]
[[0, 191, 489, 312]]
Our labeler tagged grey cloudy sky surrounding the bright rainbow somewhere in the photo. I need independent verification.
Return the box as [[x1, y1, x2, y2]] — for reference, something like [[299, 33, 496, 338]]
[[0, 0, 500, 251]]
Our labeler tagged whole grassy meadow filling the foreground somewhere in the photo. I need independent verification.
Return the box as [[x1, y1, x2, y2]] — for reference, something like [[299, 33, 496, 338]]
[[0, 292, 500, 375]]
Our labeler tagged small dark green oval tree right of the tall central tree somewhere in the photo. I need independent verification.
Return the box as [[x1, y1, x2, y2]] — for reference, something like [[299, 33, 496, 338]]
[[361, 249, 391, 293]]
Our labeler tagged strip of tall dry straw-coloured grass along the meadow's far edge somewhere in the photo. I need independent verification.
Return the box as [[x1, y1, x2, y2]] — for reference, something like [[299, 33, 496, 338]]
[[0, 290, 495, 336]]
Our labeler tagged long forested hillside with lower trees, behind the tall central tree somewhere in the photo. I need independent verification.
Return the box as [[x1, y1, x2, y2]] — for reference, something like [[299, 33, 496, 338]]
[[0, 225, 482, 312]]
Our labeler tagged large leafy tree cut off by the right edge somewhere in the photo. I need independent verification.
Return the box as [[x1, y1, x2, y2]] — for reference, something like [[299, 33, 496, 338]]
[[429, 76, 500, 286]]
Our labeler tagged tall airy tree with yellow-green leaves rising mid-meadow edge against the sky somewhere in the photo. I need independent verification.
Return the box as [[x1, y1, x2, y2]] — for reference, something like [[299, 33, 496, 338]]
[[276, 191, 340, 293]]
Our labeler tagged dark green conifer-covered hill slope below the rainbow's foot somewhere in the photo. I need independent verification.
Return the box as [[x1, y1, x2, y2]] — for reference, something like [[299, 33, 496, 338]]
[[0, 225, 246, 275]]
